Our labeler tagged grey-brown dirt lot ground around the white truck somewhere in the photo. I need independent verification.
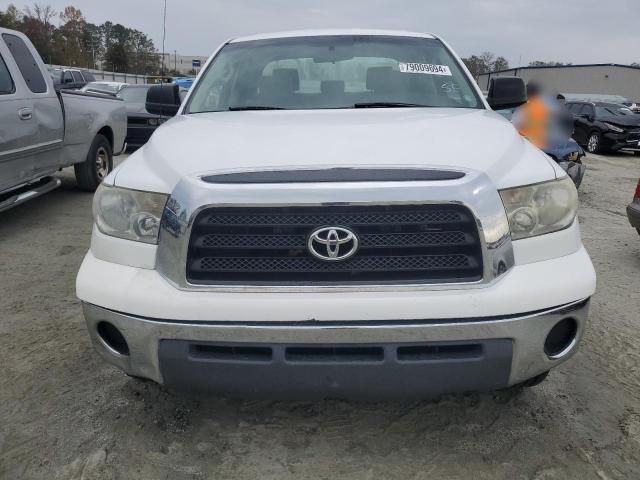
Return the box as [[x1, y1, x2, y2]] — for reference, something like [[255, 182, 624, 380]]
[[0, 155, 640, 480]]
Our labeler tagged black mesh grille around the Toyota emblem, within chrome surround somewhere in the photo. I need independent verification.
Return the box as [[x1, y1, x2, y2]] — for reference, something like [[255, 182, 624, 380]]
[[187, 204, 482, 285]]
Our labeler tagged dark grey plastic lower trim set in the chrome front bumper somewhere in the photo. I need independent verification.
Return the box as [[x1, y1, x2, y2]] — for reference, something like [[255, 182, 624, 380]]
[[158, 339, 513, 400]]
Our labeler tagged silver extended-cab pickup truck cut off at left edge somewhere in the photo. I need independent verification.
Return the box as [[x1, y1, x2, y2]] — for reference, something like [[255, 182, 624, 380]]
[[0, 28, 127, 211]]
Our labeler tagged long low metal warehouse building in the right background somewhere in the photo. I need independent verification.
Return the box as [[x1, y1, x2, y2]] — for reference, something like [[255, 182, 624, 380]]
[[478, 63, 640, 102]]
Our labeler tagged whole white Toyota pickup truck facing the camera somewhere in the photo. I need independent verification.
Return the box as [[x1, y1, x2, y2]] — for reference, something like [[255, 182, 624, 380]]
[[77, 30, 596, 399]]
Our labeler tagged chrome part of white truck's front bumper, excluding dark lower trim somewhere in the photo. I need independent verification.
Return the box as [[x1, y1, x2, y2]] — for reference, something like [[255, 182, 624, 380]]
[[83, 299, 589, 398]]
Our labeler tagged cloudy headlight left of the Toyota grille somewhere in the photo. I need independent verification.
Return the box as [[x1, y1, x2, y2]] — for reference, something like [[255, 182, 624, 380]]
[[93, 183, 168, 243]]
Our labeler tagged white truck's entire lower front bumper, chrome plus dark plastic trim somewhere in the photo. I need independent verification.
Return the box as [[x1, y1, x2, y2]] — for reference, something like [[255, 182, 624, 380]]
[[83, 299, 589, 399]]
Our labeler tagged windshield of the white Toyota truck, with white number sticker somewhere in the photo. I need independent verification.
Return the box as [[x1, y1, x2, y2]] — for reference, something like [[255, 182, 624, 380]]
[[186, 36, 483, 113]]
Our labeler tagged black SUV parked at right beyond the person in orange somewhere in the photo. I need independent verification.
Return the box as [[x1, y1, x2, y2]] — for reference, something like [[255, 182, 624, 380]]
[[566, 102, 640, 155]]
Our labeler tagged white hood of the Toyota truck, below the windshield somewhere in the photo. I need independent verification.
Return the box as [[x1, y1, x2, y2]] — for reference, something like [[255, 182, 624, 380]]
[[112, 108, 558, 193]]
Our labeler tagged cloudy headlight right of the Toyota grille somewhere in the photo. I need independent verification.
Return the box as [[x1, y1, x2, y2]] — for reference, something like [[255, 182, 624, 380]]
[[500, 177, 578, 240]]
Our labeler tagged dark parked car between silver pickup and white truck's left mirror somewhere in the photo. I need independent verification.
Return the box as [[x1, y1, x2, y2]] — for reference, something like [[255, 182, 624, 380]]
[[118, 85, 167, 151]]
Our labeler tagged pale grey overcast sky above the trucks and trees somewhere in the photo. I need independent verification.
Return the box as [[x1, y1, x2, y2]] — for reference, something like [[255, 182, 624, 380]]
[[10, 0, 640, 66]]
